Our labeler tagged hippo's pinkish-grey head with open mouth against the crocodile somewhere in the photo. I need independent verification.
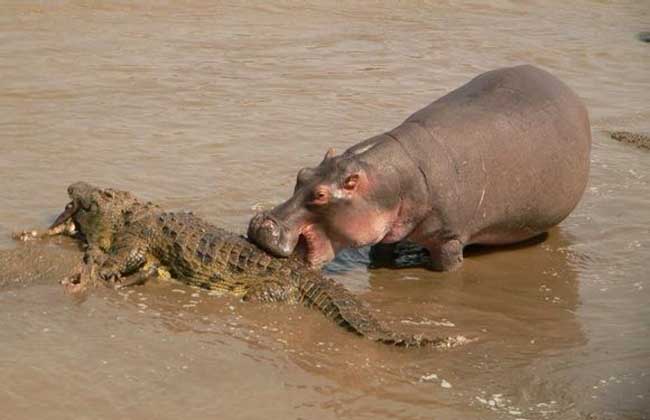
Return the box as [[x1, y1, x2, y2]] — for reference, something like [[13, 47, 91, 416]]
[[248, 149, 399, 267]]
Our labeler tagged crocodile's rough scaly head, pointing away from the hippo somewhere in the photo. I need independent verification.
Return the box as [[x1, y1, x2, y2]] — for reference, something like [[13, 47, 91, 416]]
[[49, 182, 139, 250]]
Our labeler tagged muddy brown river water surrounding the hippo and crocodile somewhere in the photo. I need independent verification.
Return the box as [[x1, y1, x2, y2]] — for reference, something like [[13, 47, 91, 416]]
[[0, 0, 650, 420]]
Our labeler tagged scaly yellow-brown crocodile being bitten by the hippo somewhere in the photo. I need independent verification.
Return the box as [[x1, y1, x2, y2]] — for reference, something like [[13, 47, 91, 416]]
[[18, 182, 462, 347]]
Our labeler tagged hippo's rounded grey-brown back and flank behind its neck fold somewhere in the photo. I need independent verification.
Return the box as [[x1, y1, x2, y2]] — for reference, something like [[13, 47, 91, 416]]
[[391, 65, 591, 243]]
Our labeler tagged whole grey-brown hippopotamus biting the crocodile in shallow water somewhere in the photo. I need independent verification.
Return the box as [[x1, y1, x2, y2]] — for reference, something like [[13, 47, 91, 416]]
[[248, 65, 591, 271]]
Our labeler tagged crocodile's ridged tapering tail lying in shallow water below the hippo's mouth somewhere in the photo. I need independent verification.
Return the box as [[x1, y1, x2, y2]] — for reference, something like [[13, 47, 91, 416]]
[[297, 275, 455, 347]]
